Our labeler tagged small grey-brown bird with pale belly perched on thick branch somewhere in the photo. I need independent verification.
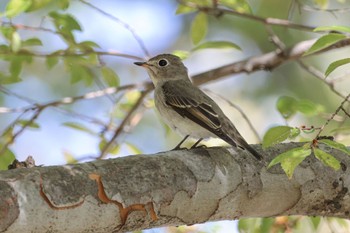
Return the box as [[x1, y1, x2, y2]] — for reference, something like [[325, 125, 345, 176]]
[[134, 54, 262, 160]]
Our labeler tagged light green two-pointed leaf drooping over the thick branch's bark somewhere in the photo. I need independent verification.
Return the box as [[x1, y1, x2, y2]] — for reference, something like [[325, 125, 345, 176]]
[[268, 147, 311, 179]]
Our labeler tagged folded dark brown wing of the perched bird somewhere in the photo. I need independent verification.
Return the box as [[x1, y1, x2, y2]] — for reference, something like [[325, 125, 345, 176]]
[[162, 81, 225, 137]]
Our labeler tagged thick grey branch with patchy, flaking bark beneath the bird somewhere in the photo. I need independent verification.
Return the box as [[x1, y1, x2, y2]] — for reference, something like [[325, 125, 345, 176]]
[[0, 143, 350, 233]]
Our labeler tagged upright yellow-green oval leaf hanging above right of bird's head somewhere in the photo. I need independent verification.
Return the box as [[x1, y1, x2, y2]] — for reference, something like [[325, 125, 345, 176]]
[[191, 12, 208, 45]]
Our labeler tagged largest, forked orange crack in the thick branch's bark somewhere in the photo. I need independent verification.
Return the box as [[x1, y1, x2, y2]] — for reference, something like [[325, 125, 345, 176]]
[[89, 173, 158, 226]]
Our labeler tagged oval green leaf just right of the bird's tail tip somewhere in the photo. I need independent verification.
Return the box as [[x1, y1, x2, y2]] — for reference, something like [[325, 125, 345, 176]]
[[262, 126, 293, 149]]
